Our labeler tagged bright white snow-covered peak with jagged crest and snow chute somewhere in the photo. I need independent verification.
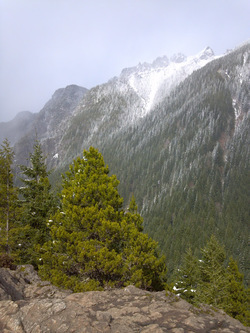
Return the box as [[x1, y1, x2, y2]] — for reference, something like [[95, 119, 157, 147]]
[[119, 47, 215, 119]]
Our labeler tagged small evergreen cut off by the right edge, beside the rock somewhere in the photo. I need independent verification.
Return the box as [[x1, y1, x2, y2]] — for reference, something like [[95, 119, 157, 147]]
[[223, 258, 250, 325]]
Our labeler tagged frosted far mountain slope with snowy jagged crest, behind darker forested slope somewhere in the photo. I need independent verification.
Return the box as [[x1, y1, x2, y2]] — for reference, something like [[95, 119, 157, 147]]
[[49, 47, 215, 165]]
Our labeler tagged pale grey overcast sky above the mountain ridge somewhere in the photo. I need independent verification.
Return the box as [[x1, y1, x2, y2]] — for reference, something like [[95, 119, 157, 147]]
[[0, 0, 250, 121]]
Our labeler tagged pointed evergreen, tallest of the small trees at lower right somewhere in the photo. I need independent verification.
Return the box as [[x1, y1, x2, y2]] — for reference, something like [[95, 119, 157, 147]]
[[196, 235, 227, 307]]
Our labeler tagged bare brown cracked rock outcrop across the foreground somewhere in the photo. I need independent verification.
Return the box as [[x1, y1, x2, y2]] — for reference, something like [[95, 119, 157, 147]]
[[0, 265, 249, 333]]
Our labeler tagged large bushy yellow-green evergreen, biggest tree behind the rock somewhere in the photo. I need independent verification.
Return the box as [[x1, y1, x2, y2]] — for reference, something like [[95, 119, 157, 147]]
[[39, 147, 166, 291]]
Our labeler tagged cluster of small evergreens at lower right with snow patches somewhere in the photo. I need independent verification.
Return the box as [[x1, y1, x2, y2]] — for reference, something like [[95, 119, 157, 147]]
[[173, 235, 249, 325]]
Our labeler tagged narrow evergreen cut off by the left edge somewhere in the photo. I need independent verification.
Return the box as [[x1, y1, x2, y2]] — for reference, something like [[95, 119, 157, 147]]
[[0, 139, 17, 254]]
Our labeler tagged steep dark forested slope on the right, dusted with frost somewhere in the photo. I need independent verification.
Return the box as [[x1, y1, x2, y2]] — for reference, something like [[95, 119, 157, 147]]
[[102, 41, 250, 278]]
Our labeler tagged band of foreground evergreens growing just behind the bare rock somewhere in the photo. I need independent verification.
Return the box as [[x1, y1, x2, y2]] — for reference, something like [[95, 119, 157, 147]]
[[0, 140, 249, 325]]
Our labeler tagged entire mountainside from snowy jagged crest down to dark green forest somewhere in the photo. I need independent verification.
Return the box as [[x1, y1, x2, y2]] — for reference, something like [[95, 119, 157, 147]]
[[2, 44, 250, 278]]
